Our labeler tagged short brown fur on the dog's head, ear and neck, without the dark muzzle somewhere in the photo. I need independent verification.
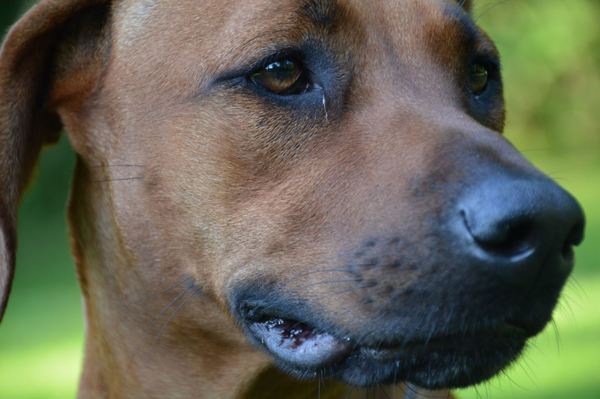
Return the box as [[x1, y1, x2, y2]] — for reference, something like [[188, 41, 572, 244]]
[[0, 0, 544, 398]]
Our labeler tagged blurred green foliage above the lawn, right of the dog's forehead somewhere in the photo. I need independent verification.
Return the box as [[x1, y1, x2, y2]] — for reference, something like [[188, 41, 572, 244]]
[[474, 0, 600, 156]]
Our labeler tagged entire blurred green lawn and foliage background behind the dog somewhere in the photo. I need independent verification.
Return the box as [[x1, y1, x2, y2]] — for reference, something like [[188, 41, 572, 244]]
[[0, 0, 600, 399]]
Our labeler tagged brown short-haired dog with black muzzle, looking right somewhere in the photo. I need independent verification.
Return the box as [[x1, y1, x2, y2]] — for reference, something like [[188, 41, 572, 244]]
[[0, 0, 584, 398]]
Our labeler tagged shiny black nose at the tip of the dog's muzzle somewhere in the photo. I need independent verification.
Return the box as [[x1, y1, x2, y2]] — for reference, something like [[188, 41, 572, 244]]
[[459, 176, 584, 284]]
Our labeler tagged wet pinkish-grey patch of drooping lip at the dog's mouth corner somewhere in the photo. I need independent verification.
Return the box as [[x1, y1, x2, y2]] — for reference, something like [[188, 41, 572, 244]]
[[248, 318, 352, 369]]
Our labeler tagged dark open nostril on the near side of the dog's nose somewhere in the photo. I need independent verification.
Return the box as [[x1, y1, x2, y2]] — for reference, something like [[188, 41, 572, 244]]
[[461, 211, 539, 259]]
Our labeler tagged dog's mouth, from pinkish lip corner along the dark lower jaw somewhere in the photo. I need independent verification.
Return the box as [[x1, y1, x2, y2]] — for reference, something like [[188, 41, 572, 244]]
[[241, 305, 534, 389]]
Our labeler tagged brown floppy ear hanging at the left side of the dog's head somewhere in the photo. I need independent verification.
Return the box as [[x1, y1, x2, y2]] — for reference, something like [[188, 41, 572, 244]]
[[0, 0, 111, 319]]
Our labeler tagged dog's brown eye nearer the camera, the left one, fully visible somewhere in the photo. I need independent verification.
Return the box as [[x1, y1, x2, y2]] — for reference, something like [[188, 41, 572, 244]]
[[250, 59, 308, 95]]
